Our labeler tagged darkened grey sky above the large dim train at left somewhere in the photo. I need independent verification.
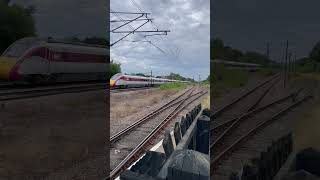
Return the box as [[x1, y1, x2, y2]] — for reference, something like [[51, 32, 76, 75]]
[[11, 0, 107, 38]]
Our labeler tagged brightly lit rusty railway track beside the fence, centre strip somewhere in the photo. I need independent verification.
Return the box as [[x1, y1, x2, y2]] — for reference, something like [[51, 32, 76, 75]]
[[108, 88, 207, 179]]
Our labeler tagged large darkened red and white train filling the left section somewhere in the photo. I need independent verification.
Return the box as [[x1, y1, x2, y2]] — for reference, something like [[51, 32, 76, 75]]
[[0, 37, 109, 84]]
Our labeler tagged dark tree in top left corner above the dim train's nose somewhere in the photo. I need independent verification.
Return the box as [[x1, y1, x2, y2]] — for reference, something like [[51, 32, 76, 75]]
[[0, 0, 36, 53]]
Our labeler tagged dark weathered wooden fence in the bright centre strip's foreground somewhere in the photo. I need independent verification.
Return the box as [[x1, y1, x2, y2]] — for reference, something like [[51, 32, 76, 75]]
[[120, 105, 210, 180]]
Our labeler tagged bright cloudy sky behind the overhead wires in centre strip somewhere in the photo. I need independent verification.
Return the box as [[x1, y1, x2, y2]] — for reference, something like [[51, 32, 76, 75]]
[[110, 0, 210, 80]]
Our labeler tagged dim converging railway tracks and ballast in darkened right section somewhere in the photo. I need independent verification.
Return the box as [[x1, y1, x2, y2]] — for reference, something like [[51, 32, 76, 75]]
[[210, 73, 312, 180]]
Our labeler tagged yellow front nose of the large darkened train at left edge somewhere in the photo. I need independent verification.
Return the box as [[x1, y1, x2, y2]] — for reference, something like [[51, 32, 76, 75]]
[[0, 56, 17, 80]]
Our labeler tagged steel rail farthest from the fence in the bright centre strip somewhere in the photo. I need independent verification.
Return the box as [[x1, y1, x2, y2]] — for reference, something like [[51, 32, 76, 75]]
[[110, 88, 194, 144]]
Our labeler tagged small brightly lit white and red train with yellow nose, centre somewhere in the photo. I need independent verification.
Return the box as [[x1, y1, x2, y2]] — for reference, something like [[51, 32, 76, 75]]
[[110, 73, 189, 88]]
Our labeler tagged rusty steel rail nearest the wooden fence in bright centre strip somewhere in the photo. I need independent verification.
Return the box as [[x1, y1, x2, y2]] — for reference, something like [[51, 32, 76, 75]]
[[108, 91, 207, 179]]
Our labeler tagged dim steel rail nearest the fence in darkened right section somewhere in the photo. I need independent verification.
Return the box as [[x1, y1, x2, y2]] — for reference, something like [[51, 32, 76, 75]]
[[210, 95, 313, 169]]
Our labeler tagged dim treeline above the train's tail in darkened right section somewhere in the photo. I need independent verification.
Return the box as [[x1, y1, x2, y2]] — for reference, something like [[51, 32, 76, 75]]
[[210, 38, 272, 65]]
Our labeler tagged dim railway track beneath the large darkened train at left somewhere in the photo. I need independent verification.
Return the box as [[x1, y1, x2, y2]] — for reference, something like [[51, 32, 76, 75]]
[[0, 83, 106, 101]]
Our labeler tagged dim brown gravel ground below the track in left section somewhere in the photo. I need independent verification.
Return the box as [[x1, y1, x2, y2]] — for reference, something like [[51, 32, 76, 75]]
[[0, 90, 106, 180]]
